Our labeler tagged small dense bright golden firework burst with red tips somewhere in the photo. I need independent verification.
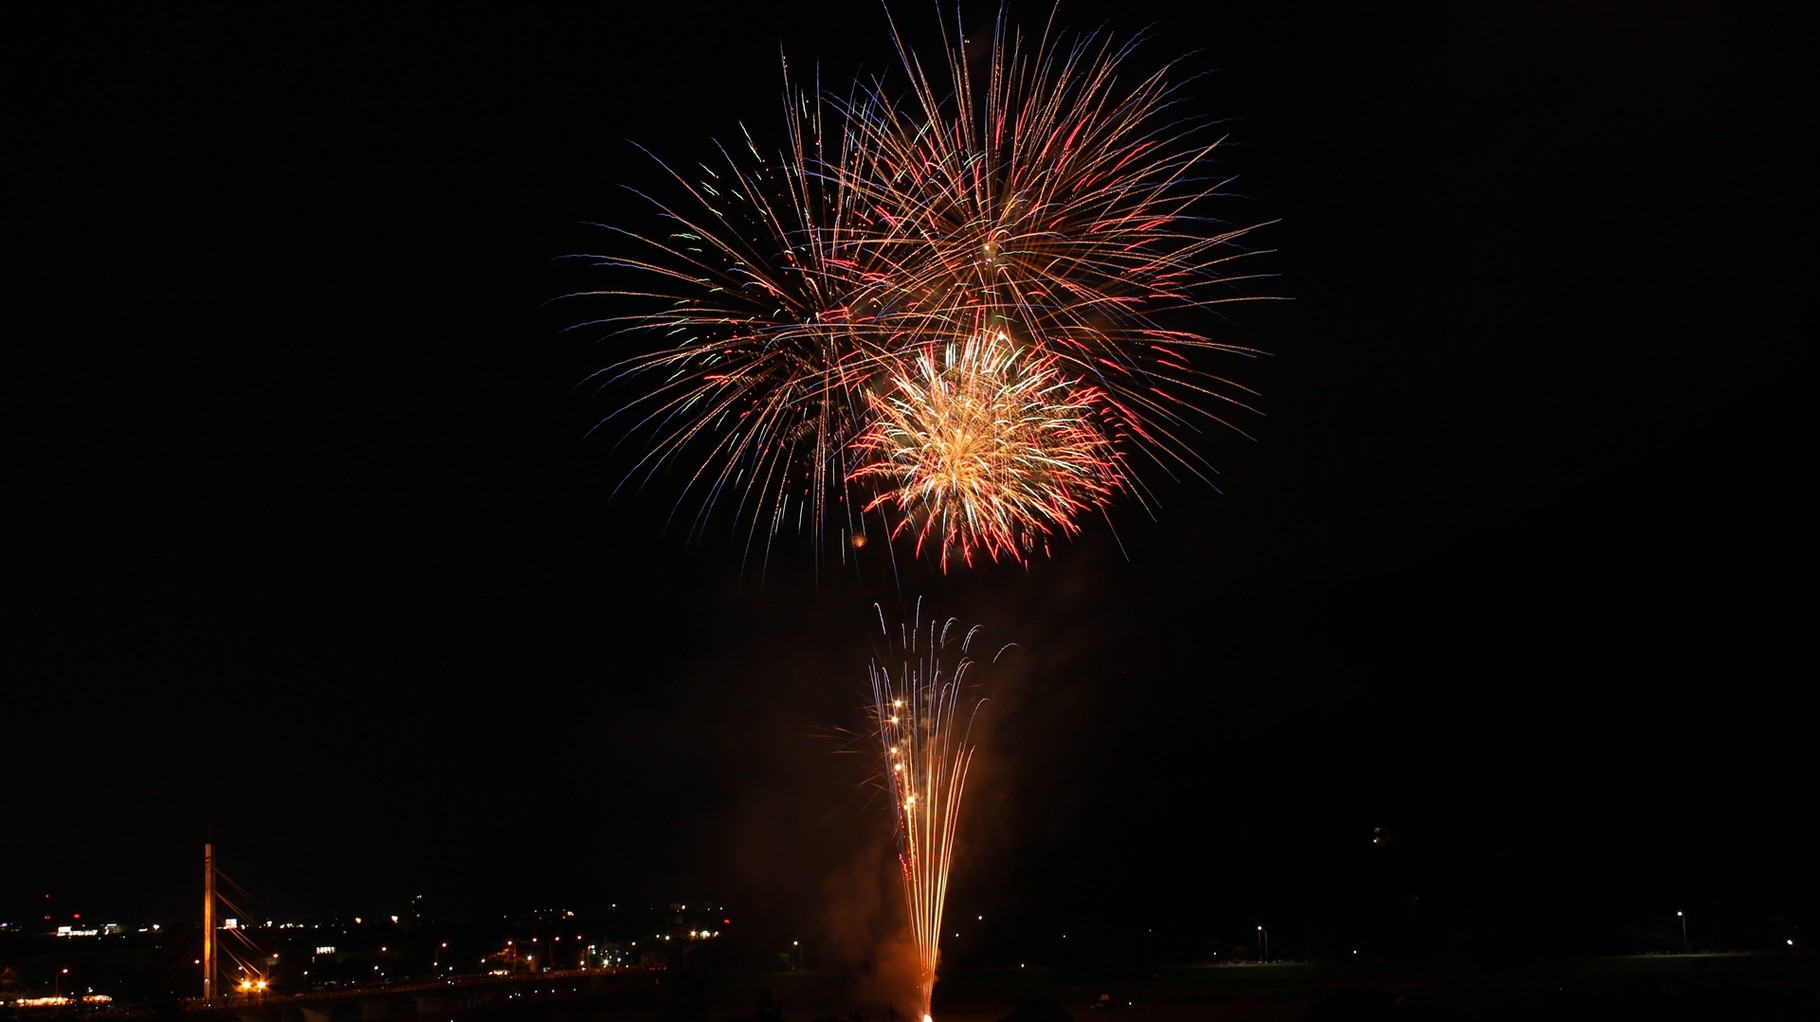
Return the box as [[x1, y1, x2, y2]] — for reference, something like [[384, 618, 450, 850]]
[[852, 325, 1125, 569]]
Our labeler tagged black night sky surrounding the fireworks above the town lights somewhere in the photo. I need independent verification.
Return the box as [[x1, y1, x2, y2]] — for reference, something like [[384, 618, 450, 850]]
[[10, 2, 1820, 960]]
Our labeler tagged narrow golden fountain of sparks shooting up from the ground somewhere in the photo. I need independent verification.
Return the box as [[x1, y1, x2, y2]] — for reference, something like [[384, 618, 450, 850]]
[[872, 600, 1010, 1022]]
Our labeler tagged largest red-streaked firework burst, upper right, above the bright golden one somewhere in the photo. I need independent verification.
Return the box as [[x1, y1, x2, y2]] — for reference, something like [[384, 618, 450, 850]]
[[841, 2, 1258, 498]]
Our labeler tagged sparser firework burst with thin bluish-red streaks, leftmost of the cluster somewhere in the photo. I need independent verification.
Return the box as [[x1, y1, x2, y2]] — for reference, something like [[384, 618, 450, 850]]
[[568, 71, 888, 549]]
